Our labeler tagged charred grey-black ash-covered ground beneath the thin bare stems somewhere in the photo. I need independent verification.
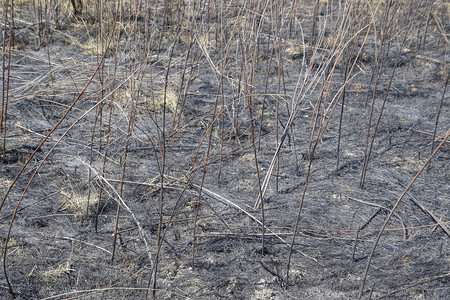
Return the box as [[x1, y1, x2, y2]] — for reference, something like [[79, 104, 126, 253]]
[[0, 1, 450, 299]]
